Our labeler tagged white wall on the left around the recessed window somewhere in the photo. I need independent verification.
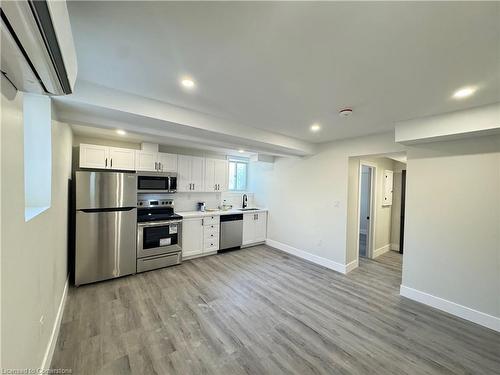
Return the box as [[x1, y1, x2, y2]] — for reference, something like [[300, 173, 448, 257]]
[[1, 77, 72, 368]]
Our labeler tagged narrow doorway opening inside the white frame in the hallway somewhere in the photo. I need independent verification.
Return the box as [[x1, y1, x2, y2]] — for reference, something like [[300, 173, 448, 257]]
[[358, 162, 376, 258]]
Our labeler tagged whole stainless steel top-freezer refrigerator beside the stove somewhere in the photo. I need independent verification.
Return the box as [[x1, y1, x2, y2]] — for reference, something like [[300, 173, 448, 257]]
[[75, 171, 137, 285]]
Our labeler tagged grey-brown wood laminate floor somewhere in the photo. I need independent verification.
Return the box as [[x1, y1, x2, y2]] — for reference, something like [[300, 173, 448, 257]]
[[52, 246, 500, 375]]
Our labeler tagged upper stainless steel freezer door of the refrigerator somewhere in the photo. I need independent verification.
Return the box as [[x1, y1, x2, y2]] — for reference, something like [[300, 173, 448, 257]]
[[75, 171, 137, 210]]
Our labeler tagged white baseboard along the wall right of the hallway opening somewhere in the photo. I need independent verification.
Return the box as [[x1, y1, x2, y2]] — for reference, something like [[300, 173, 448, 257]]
[[399, 285, 500, 332]]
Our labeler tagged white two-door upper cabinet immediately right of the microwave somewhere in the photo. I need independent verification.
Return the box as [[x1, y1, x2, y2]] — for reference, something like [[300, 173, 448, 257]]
[[177, 155, 205, 192]]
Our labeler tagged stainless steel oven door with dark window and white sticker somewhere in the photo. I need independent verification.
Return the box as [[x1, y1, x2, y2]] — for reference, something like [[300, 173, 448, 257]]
[[137, 220, 182, 258]]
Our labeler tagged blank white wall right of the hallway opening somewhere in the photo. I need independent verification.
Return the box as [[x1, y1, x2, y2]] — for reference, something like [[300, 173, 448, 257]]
[[403, 136, 500, 324]]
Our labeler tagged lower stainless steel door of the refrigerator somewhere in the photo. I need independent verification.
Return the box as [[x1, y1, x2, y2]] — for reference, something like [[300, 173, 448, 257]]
[[75, 208, 137, 285]]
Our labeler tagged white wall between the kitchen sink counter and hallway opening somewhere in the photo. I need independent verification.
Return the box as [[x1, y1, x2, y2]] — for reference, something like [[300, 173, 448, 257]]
[[251, 133, 404, 265]]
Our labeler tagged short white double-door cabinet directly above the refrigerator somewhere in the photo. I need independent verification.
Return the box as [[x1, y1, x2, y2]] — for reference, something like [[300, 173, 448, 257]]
[[80, 143, 135, 171]]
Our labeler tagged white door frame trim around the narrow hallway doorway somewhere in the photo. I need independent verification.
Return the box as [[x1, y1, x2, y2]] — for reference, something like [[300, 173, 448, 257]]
[[356, 160, 377, 264]]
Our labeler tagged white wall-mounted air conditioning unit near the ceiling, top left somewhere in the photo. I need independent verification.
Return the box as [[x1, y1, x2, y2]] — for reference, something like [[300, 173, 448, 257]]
[[1, 0, 77, 95]]
